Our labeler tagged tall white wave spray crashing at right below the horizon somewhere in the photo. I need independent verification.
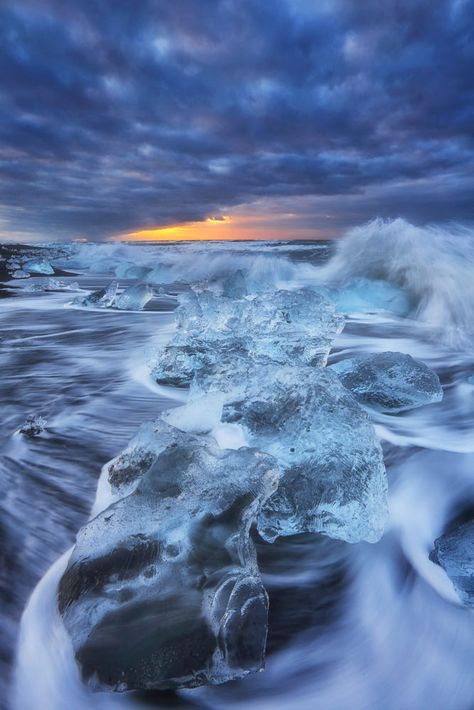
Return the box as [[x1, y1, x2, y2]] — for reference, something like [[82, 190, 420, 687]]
[[318, 219, 474, 343]]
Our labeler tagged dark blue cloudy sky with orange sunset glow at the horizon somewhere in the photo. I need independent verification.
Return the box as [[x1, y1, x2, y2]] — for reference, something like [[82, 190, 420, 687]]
[[0, 0, 474, 242]]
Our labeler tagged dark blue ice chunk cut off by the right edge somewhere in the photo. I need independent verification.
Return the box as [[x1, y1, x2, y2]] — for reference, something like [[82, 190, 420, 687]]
[[430, 520, 474, 608]]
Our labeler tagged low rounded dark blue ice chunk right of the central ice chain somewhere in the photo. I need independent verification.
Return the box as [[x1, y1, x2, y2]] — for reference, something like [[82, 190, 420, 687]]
[[331, 352, 443, 413]]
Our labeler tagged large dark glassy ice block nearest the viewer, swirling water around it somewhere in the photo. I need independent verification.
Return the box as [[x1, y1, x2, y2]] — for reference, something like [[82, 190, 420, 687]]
[[58, 422, 278, 691]]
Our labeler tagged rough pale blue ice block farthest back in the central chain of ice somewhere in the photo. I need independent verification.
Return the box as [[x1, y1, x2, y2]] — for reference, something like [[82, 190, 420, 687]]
[[153, 289, 344, 386]]
